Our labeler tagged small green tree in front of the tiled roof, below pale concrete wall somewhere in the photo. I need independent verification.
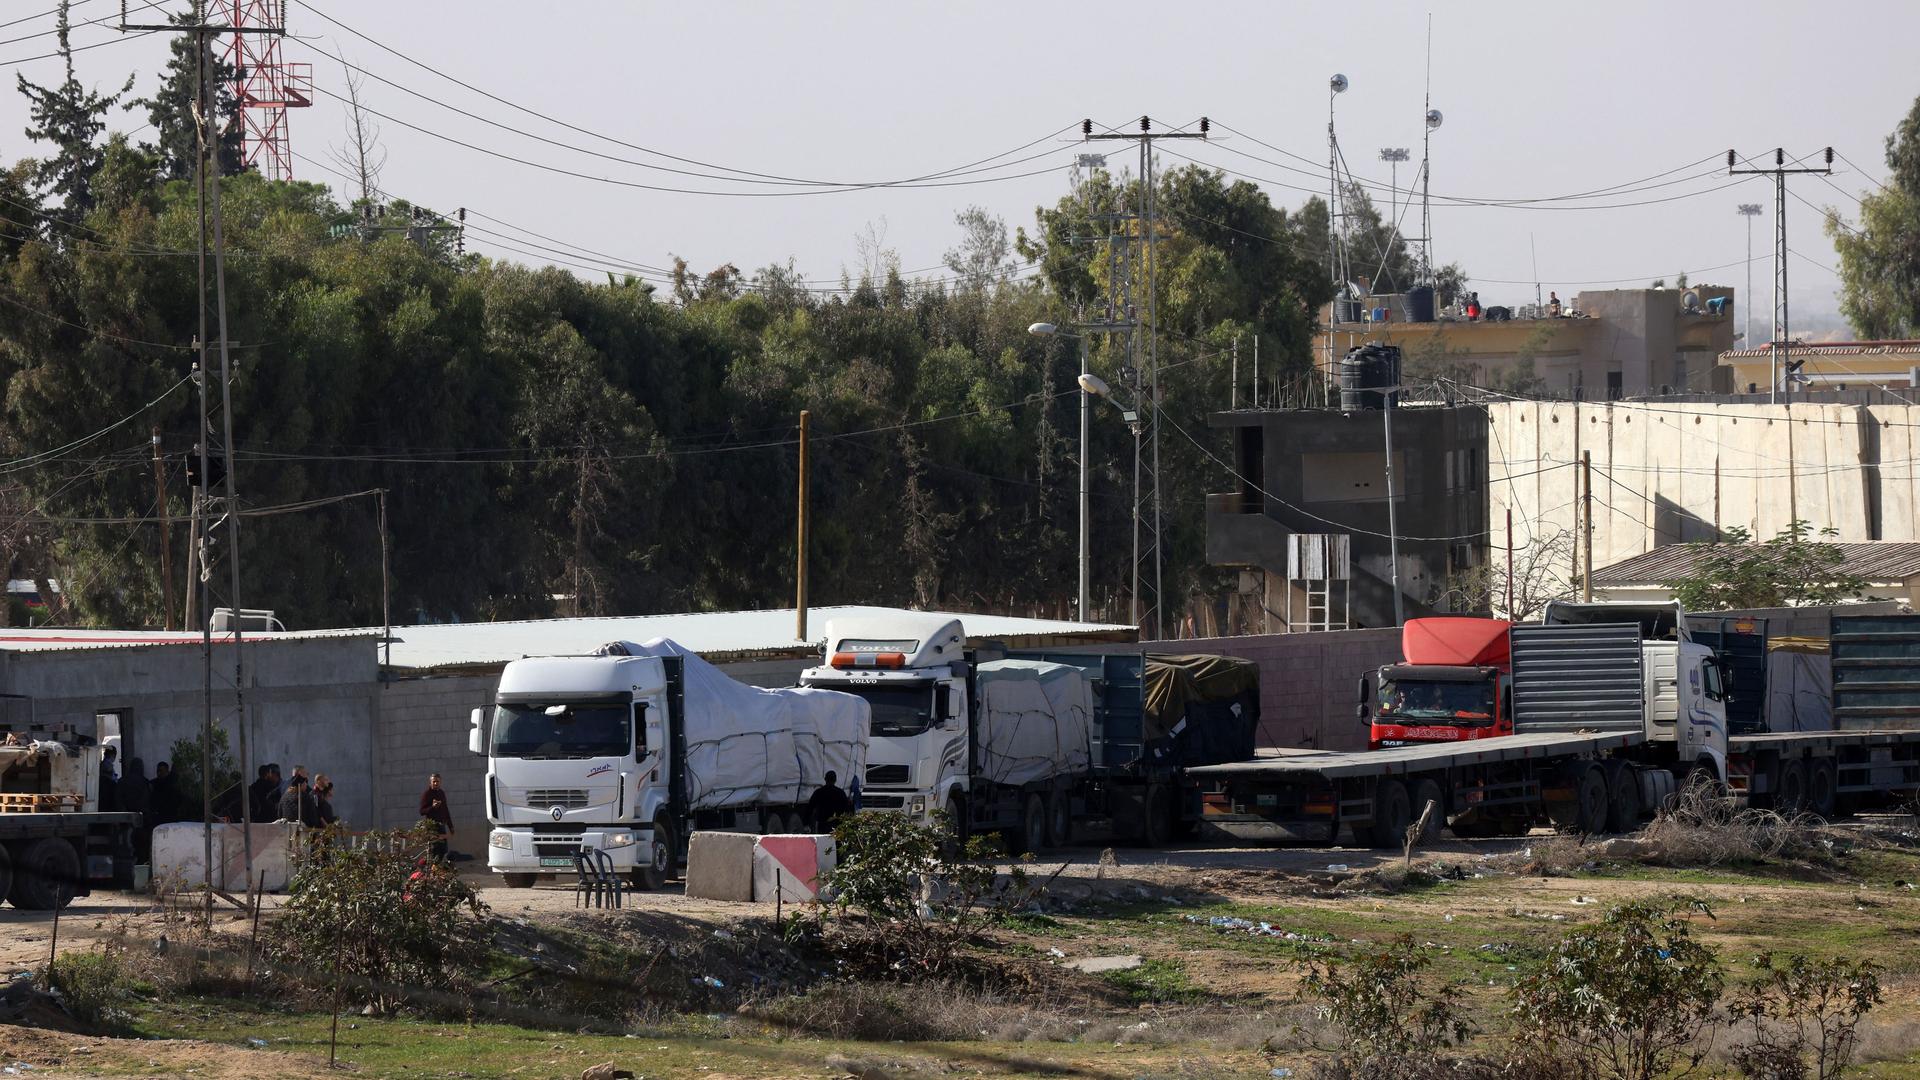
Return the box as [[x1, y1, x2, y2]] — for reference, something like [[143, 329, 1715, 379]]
[[1661, 521, 1866, 611]]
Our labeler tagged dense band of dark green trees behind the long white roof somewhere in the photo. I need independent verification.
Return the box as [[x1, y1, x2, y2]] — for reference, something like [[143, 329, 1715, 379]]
[[0, 27, 1382, 628]]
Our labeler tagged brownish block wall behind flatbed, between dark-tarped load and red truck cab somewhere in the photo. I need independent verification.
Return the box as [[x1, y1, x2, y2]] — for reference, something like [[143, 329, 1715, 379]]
[[1140, 626, 1400, 749]]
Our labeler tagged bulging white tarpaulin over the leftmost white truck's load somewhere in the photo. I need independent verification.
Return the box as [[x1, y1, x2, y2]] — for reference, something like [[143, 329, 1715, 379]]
[[601, 638, 870, 809]]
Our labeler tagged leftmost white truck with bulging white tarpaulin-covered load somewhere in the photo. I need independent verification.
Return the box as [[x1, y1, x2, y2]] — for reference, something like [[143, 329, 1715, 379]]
[[468, 640, 870, 888]]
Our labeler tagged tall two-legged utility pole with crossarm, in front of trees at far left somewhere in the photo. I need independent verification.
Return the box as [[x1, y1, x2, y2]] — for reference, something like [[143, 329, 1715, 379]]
[[119, 0, 286, 907]]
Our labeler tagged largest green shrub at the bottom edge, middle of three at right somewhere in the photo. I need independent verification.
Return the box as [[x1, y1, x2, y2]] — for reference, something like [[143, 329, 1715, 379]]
[[1513, 899, 1724, 1080]]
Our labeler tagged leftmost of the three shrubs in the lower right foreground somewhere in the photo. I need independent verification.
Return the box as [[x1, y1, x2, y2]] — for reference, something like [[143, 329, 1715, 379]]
[[1306, 936, 1473, 1070]]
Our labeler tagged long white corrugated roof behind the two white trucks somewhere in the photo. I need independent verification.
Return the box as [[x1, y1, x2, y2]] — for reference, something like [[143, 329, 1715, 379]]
[[392, 605, 1135, 669]]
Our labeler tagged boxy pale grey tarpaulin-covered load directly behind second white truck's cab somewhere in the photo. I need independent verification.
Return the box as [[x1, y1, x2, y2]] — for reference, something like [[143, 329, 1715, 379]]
[[977, 659, 1092, 784]]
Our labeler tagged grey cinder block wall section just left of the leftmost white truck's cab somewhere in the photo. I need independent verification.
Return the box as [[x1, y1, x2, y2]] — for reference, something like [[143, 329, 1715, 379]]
[[376, 675, 499, 834]]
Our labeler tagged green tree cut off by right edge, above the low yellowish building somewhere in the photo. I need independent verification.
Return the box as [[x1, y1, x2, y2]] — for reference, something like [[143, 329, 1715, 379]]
[[1826, 98, 1920, 340]]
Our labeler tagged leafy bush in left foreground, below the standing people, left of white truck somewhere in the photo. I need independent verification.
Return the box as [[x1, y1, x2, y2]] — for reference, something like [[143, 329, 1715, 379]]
[[263, 828, 486, 1009]]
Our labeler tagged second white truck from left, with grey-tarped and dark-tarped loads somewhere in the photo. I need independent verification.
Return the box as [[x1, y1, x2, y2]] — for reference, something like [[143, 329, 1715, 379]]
[[801, 613, 1260, 853]]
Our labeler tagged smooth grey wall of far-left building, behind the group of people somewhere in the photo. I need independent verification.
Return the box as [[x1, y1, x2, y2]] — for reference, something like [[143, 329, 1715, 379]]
[[0, 638, 378, 824]]
